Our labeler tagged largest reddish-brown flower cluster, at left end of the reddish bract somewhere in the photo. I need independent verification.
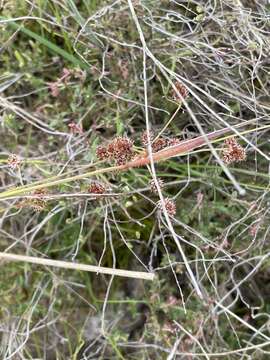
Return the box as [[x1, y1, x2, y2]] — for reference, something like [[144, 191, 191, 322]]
[[96, 136, 134, 165]]
